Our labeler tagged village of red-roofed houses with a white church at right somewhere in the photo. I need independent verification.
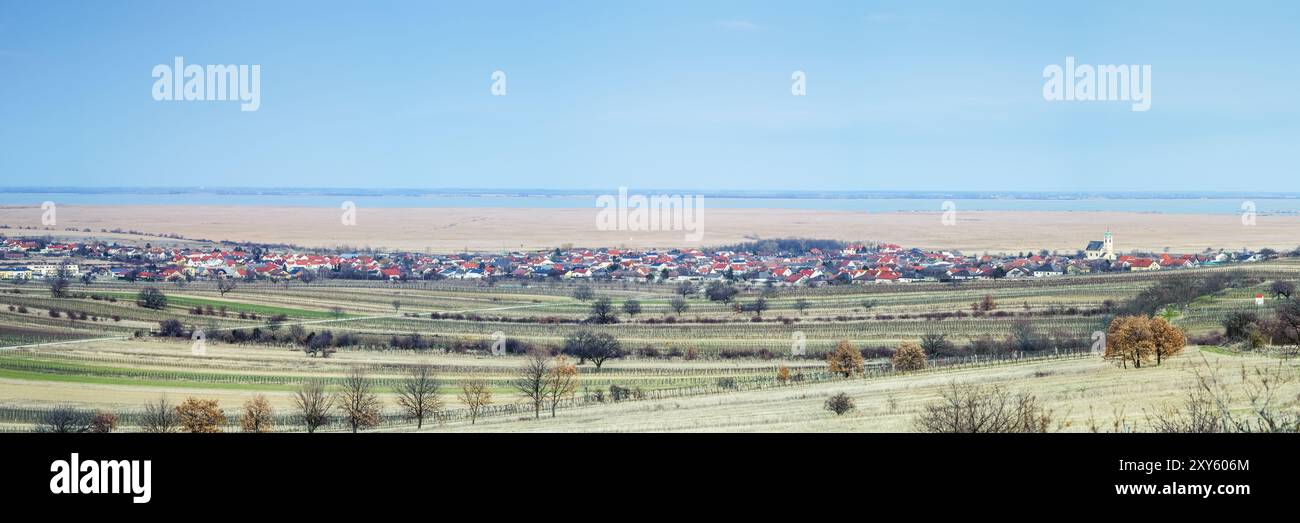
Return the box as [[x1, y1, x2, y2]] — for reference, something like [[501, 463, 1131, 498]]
[[0, 232, 1277, 286]]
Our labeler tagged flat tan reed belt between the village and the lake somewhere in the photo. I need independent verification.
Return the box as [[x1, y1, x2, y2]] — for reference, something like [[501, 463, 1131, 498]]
[[0, 206, 1300, 252]]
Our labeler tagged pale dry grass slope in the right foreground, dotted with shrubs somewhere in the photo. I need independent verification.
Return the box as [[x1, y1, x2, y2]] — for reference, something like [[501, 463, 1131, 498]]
[[430, 349, 1300, 432]]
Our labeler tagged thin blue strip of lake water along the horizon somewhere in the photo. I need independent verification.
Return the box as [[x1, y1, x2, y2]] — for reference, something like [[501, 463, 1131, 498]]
[[0, 190, 1300, 215]]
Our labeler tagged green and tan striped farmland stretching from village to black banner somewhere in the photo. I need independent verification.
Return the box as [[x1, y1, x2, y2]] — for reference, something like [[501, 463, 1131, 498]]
[[0, 260, 1300, 431]]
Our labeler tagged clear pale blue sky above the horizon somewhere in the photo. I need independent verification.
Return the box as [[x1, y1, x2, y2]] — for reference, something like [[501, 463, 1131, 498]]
[[0, 1, 1300, 191]]
